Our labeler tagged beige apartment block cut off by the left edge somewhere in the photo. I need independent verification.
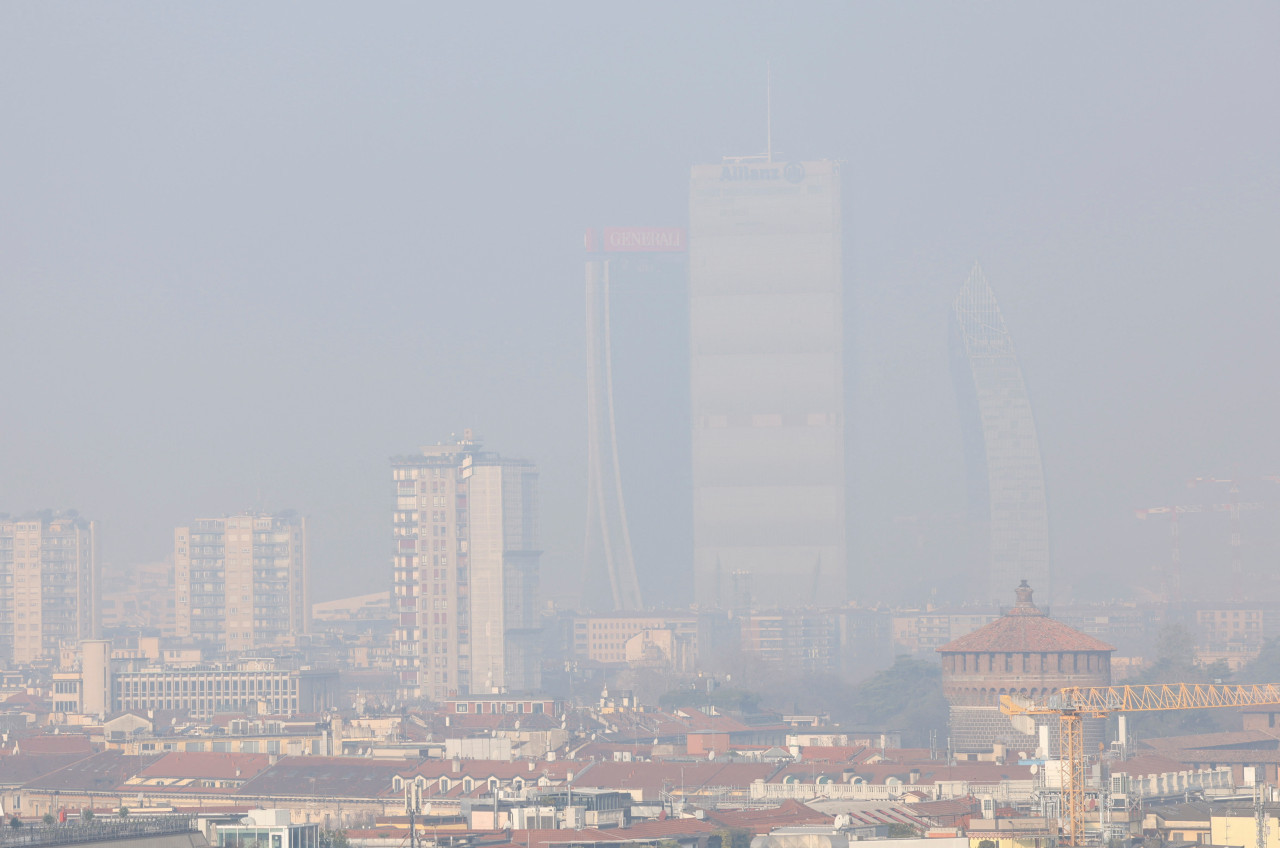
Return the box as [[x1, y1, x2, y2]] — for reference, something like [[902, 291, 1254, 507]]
[[0, 512, 97, 665]]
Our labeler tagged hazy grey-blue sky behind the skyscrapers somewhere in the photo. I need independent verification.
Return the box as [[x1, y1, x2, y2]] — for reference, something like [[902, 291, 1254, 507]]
[[0, 1, 1280, 599]]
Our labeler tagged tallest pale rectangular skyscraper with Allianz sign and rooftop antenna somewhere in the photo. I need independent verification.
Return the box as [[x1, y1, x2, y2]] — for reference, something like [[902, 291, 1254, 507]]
[[689, 156, 847, 608]]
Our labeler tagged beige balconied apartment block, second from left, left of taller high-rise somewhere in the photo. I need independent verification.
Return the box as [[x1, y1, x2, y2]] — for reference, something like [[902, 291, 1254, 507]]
[[173, 512, 311, 653]]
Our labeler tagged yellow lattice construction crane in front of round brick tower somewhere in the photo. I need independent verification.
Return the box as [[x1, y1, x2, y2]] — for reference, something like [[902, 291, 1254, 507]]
[[1000, 683, 1280, 845]]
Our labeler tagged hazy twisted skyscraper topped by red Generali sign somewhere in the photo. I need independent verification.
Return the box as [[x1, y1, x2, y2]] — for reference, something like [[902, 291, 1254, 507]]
[[582, 227, 692, 611]]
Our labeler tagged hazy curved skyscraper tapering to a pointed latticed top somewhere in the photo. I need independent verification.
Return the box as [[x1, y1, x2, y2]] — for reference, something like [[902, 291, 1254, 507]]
[[954, 265, 1051, 599]]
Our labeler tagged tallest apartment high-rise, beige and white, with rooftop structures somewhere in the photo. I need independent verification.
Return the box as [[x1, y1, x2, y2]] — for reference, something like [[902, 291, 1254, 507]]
[[392, 430, 540, 701]]
